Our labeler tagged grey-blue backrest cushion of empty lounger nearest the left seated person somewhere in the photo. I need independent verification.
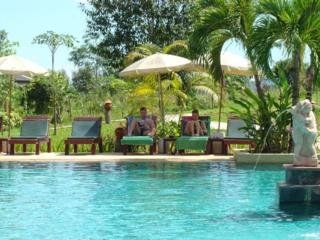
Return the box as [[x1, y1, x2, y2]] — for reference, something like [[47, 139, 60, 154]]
[[71, 120, 101, 138]]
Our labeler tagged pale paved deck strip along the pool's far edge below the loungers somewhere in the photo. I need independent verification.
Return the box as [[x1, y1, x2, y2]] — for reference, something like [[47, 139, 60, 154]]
[[0, 153, 233, 163]]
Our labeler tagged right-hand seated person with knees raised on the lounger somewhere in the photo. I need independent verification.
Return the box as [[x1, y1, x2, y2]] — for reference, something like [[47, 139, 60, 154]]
[[184, 109, 207, 136]]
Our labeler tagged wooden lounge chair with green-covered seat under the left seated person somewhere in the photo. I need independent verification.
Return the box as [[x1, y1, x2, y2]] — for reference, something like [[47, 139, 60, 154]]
[[121, 116, 157, 155]]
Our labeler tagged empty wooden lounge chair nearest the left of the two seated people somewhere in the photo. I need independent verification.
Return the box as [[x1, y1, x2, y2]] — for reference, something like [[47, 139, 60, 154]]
[[64, 117, 102, 155]]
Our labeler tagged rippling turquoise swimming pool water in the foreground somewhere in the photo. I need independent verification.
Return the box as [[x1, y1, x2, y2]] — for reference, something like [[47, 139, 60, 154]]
[[0, 162, 320, 240]]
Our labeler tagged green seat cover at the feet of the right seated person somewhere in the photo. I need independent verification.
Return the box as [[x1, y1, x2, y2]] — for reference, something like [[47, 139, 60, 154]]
[[176, 136, 208, 151]]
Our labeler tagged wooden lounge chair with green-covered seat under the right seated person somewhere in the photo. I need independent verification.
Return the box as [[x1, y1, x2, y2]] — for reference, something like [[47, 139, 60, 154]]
[[176, 116, 210, 154]]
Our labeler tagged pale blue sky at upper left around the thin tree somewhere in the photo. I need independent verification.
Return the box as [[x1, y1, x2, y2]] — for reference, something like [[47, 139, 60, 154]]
[[0, 0, 86, 74]]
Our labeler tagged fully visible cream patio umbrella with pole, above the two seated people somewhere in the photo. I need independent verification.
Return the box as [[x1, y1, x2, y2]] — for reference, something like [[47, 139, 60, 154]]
[[120, 53, 193, 126]]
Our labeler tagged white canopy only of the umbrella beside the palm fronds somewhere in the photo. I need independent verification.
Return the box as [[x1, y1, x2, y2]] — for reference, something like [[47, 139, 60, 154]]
[[220, 52, 253, 76]]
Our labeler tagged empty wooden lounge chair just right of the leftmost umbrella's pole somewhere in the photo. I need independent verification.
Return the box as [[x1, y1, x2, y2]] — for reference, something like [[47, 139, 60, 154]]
[[8, 116, 51, 155]]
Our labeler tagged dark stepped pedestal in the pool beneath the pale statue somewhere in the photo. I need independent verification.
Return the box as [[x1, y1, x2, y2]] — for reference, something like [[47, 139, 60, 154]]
[[278, 164, 320, 204]]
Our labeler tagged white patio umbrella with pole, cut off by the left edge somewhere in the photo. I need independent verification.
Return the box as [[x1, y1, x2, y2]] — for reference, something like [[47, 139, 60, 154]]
[[0, 55, 48, 137]]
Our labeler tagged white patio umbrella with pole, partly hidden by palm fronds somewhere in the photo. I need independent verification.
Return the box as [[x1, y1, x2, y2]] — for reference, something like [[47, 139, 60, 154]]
[[218, 52, 254, 132]]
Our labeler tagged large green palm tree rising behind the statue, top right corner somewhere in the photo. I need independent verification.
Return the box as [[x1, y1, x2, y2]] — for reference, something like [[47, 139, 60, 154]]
[[252, 0, 320, 104]]
